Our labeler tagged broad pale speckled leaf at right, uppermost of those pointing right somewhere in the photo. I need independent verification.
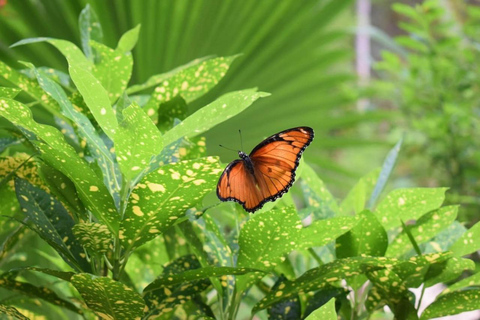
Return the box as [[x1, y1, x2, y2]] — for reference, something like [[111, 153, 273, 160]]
[[374, 188, 447, 231]]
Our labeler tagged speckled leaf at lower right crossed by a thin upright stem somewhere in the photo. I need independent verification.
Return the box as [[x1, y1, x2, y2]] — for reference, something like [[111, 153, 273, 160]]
[[386, 206, 458, 257]]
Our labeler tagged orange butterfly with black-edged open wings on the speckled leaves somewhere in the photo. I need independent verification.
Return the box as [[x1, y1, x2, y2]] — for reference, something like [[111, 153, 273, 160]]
[[217, 127, 314, 212]]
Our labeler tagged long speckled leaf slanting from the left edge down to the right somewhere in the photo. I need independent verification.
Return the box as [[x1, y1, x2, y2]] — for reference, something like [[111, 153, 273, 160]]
[[0, 99, 119, 232]]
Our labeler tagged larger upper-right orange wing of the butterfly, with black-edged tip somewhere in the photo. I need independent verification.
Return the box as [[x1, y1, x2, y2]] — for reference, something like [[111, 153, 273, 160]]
[[249, 127, 314, 208]]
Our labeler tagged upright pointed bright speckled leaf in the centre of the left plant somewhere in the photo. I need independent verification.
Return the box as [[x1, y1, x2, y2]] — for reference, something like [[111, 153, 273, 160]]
[[114, 103, 163, 183]]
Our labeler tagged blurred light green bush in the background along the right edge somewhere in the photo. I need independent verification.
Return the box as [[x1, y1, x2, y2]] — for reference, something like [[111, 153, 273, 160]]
[[374, 0, 480, 222]]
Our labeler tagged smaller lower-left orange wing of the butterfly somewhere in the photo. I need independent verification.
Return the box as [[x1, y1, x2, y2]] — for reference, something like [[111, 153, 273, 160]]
[[217, 160, 263, 212]]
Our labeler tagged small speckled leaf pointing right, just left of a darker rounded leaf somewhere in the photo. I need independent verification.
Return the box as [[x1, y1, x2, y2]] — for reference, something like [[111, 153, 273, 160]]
[[301, 217, 359, 248]]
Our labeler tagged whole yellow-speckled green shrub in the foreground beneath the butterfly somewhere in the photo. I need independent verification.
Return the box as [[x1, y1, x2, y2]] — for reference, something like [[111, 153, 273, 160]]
[[0, 3, 480, 319]]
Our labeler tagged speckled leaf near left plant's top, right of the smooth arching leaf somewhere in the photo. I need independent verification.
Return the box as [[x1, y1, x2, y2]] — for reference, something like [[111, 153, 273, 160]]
[[90, 41, 133, 104]]
